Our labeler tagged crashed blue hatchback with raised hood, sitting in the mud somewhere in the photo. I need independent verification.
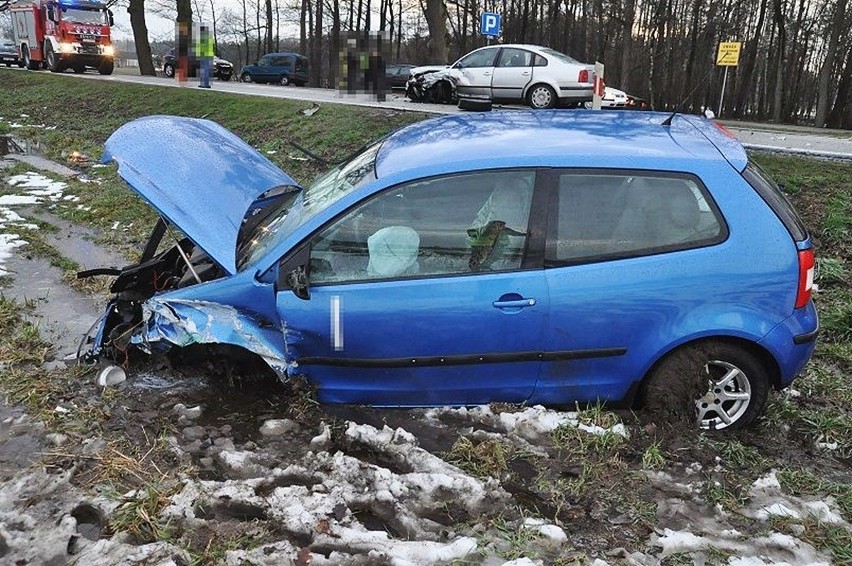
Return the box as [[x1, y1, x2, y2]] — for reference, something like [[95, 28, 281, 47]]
[[81, 110, 818, 429]]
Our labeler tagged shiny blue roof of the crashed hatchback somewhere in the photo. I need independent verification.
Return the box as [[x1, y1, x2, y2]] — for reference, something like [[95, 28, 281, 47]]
[[376, 110, 747, 181]]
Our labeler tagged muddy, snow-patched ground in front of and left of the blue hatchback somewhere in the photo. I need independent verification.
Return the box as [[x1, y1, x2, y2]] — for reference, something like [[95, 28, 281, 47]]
[[0, 152, 852, 565]]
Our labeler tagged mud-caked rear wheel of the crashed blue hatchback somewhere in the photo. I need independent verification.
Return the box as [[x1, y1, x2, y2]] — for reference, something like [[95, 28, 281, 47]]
[[642, 341, 769, 430]]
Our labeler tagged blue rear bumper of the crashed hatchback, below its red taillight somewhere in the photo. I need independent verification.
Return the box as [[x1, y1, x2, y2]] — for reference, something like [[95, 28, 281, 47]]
[[759, 301, 819, 387]]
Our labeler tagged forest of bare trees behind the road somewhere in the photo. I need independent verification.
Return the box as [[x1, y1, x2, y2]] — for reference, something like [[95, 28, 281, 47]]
[[1, 0, 852, 129]]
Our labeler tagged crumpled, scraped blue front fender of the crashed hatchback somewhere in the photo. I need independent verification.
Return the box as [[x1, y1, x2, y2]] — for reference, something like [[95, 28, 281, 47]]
[[130, 298, 294, 378]]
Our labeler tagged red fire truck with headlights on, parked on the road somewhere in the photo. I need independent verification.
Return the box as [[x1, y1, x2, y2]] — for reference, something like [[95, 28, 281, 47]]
[[9, 0, 115, 75]]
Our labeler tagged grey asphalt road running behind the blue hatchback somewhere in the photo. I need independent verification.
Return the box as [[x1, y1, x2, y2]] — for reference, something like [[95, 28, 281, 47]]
[[6, 69, 852, 160]]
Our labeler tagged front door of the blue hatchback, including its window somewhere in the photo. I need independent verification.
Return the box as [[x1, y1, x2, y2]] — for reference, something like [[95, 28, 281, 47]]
[[277, 170, 548, 406]]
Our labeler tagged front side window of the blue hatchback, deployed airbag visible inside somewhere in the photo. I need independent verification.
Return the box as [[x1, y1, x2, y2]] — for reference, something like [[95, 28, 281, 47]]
[[310, 171, 535, 285]]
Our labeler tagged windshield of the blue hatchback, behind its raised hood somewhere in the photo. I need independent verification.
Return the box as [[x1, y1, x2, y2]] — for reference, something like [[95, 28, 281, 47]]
[[237, 142, 381, 271]]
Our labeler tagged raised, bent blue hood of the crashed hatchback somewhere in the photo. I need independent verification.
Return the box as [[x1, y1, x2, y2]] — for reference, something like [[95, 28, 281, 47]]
[[102, 116, 297, 274]]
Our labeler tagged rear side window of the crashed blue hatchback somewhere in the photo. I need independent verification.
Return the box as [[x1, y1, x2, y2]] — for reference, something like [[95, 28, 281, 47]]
[[546, 173, 727, 265]]
